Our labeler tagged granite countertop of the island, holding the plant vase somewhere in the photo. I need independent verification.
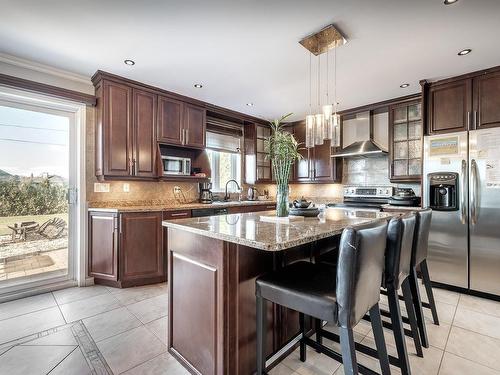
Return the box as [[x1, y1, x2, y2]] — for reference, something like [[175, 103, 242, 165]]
[[162, 208, 394, 251]]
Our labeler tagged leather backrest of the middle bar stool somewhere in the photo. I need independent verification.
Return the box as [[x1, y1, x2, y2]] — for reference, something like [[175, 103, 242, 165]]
[[385, 212, 416, 289]]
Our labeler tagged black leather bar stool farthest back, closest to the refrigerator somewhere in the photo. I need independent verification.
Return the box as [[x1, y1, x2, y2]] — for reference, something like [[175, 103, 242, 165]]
[[410, 208, 439, 348]]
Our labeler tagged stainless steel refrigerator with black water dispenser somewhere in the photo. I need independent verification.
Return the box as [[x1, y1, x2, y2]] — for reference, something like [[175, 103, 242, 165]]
[[422, 128, 500, 295]]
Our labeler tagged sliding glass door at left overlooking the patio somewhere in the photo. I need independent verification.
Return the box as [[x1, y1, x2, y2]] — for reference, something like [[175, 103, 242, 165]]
[[0, 101, 77, 294]]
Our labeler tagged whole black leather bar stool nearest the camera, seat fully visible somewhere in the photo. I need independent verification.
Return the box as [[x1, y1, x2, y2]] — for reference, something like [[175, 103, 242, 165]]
[[255, 221, 390, 375]]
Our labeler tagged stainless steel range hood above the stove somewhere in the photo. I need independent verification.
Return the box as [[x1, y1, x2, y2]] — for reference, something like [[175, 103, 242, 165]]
[[331, 111, 389, 158]]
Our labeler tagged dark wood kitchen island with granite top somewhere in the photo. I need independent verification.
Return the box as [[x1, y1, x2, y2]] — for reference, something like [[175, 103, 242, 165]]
[[163, 208, 391, 375]]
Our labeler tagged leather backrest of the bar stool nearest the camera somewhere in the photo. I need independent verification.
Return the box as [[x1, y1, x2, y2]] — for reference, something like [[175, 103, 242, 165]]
[[336, 221, 387, 328]]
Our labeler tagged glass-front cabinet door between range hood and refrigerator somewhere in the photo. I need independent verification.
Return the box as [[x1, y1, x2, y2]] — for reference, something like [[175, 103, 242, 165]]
[[389, 100, 422, 181]]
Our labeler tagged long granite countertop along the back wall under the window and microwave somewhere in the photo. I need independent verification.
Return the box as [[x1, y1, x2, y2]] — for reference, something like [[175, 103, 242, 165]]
[[89, 199, 276, 212]]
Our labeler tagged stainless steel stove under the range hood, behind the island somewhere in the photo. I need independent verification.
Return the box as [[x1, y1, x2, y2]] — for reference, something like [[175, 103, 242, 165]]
[[328, 186, 394, 211]]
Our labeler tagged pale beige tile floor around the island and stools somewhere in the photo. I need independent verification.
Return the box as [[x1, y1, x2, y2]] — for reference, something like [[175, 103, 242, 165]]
[[0, 284, 500, 375]]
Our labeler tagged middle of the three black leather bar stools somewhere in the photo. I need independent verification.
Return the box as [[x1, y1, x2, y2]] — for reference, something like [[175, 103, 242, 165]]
[[383, 213, 423, 375]]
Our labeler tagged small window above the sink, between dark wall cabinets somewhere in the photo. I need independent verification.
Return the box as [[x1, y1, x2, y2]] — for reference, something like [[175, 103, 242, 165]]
[[207, 132, 241, 192]]
